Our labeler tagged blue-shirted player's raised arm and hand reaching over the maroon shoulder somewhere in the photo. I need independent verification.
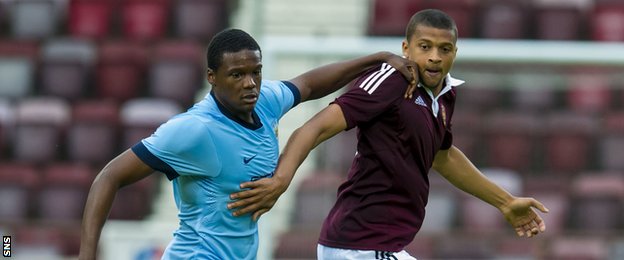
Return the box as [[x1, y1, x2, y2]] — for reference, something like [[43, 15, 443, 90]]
[[290, 51, 418, 101]]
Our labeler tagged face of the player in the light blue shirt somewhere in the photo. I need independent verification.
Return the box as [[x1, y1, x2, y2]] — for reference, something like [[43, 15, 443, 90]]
[[208, 50, 262, 120]]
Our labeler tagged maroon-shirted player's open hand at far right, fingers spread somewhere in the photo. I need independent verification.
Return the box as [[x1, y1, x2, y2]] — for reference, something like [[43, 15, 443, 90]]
[[501, 198, 548, 237]]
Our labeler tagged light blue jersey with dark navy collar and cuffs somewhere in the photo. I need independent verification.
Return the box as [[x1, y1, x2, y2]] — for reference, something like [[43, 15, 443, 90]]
[[132, 80, 300, 260]]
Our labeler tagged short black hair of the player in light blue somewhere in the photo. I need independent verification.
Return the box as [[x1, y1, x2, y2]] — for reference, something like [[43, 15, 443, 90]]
[[206, 29, 262, 71]]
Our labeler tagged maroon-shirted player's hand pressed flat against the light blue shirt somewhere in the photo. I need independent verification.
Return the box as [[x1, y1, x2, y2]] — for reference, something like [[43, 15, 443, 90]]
[[227, 177, 288, 221]]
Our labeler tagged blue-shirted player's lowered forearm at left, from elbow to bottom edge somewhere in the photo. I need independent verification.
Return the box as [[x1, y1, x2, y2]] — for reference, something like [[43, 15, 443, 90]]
[[78, 174, 118, 260]]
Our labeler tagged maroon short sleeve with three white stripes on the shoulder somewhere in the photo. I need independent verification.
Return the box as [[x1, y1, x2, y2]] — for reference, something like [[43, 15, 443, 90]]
[[333, 64, 408, 129]]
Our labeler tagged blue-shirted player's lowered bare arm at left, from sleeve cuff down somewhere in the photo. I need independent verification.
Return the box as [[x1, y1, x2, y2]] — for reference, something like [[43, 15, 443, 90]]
[[78, 150, 154, 260]]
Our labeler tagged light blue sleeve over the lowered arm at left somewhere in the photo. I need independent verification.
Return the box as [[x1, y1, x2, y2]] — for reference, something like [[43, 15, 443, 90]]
[[142, 115, 221, 179]]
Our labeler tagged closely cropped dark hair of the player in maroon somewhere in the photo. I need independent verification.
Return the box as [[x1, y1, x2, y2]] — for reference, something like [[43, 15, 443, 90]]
[[405, 9, 457, 42]]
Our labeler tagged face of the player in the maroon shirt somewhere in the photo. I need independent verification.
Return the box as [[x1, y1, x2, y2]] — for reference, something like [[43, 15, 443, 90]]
[[403, 25, 457, 90]]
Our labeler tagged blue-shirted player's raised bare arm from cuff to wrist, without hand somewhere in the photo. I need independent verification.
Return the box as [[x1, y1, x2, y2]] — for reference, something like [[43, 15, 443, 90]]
[[299, 52, 394, 100]]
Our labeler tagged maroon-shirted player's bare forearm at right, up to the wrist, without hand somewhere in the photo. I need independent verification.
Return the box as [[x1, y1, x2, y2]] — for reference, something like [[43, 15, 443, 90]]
[[434, 147, 513, 209]]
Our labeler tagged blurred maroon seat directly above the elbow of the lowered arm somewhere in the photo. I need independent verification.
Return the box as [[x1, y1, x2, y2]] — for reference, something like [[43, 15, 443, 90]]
[[67, 100, 119, 165]]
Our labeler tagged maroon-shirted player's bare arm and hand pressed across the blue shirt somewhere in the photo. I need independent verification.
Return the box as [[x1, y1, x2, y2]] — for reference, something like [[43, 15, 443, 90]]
[[228, 104, 347, 220]]
